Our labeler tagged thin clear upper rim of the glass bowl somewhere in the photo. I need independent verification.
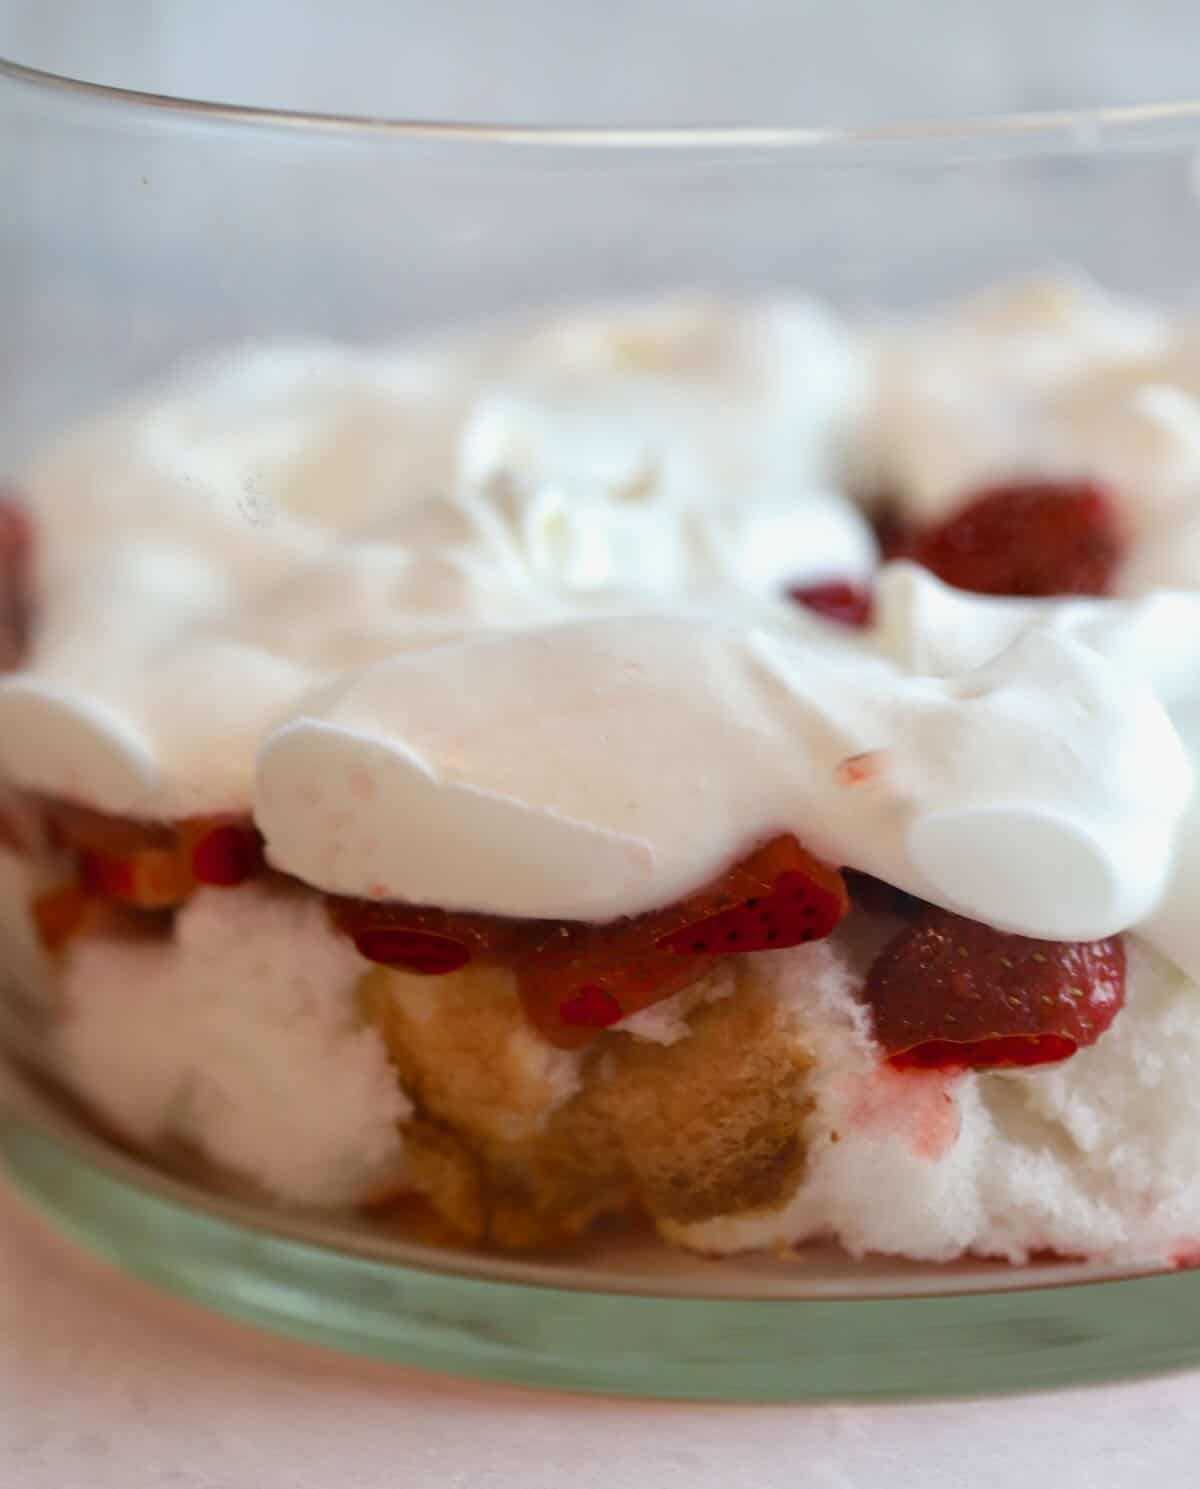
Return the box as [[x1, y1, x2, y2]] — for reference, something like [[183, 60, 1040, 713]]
[[0, 55, 1200, 156]]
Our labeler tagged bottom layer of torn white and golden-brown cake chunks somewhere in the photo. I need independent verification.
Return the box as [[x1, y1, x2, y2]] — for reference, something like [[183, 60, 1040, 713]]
[[37, 886, 1200, 1263]]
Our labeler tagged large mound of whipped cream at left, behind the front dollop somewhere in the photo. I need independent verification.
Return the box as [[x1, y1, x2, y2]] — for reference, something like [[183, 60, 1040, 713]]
[[0, 301, 875, 817]]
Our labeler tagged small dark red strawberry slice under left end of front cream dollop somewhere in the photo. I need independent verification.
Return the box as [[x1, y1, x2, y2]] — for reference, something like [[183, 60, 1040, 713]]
[[328, 895, 517, 977]]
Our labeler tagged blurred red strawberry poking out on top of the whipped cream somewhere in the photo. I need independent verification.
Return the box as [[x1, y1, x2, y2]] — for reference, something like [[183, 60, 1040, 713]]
[[911, 481, 1121, 596]]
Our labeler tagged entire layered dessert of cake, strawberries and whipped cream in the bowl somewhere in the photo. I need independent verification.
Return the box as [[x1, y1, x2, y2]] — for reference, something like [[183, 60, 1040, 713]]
[[0, 273, 1200, 1263]]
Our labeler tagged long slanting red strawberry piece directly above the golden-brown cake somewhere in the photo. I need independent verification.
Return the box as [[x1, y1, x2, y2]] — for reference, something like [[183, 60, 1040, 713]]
[[517, 835, 850, 1048]]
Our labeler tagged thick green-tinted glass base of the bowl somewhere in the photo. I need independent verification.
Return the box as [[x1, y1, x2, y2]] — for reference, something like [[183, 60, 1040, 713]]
[[0, 1077, 1200, 1401]]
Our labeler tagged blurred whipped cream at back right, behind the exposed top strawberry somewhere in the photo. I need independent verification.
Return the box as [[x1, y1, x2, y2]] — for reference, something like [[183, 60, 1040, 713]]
[[856, 278, 1200, 594]]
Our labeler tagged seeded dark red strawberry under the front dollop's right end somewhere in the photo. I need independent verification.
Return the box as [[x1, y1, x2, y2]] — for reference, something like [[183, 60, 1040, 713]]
[[864, 905, 1126, 1069]]
